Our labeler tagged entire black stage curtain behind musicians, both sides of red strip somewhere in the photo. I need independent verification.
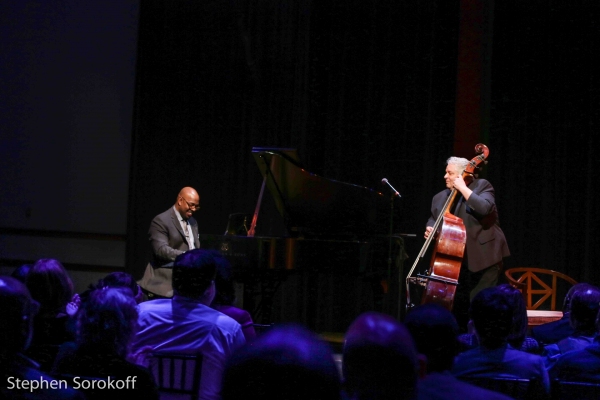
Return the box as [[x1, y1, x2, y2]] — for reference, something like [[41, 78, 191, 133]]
[[128, 0, 600, 328]]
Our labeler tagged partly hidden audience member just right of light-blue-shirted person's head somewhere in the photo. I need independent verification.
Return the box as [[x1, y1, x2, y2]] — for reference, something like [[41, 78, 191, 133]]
[[208, 250, 256, 342]]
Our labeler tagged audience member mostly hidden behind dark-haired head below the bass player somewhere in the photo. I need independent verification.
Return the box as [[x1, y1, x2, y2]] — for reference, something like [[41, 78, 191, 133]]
[[458, 283, 542, 354]]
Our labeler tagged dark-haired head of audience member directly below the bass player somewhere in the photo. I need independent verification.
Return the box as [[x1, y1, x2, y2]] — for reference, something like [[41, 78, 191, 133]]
[[469, 287, 513, 349]]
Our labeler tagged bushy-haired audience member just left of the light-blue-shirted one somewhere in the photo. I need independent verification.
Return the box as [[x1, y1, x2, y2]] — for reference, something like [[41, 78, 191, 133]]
[[53, 287, 158, 399]]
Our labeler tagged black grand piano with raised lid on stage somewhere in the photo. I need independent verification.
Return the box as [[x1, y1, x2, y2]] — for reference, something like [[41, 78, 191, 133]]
[[201, 147, 406, 332]]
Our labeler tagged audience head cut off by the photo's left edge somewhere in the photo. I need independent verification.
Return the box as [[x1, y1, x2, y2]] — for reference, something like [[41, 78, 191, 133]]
[[0, 276, 39, 358]]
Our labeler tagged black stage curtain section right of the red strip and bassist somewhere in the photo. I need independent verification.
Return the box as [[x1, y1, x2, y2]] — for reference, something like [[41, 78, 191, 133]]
[[490, 1, 600, 285]]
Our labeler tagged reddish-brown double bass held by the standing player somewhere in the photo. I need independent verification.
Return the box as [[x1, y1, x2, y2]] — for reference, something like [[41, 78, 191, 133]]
[[406, 143, 490, 310]]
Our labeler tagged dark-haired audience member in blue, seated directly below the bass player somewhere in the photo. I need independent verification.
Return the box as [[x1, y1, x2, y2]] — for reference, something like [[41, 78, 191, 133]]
[[451, 287, 550, 394]]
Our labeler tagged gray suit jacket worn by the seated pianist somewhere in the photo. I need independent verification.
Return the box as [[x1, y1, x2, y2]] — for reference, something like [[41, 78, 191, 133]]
[[138, 207, 200, 297]]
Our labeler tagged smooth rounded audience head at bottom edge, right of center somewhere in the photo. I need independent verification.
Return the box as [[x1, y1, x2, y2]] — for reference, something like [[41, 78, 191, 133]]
[[342, 312, 419, 400]]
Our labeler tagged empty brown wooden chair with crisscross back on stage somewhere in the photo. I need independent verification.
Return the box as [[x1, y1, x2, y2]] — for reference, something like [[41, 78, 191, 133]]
[[504, 267, 577, 311]]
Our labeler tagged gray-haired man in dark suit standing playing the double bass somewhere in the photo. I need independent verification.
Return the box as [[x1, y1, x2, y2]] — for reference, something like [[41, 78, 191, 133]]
[[424, 157, 510, 329]]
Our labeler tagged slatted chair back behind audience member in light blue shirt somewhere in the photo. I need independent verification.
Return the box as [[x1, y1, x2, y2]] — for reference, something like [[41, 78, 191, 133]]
[[149, 352, 203, 400]]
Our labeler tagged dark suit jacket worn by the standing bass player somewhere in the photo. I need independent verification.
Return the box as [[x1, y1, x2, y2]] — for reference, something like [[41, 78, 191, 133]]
[[427, 179, 510, 272]]
